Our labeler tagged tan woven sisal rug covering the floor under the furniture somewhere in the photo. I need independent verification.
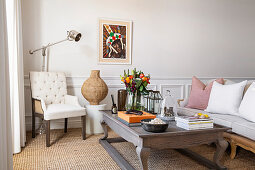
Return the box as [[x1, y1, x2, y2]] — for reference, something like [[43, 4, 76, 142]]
[[13, 129, 255, 170]]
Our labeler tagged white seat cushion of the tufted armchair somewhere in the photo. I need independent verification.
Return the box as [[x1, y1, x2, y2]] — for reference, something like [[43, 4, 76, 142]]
[[44, 104, 86, 120]]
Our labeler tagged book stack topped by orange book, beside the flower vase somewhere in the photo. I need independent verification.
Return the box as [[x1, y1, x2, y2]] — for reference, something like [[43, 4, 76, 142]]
[[118, 111, 156, 126]]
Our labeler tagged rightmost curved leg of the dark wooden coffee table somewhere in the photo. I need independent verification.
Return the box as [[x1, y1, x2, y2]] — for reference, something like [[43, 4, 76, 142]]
[[213, 139, 228, 169]]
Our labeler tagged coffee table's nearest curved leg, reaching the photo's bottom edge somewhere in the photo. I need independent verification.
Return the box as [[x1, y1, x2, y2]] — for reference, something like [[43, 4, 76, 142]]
[[136, 147, 150, 170]]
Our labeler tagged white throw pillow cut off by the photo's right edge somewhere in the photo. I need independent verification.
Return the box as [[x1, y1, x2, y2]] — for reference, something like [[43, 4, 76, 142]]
[[239, 82, 255, 122]]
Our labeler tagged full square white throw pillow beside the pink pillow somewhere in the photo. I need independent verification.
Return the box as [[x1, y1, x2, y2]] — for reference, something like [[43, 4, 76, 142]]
[[206, 80, 247, 115]]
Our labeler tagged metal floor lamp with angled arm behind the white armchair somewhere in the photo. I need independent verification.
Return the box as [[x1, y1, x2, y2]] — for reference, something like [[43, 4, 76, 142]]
[[29, 30, 81, 71]]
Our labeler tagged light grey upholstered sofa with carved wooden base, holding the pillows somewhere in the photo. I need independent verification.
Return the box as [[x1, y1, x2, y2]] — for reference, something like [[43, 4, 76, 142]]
[[176, 80, 255, 159]]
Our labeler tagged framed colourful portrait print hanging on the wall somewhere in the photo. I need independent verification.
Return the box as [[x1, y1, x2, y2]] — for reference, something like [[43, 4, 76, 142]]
[[99, 19, 132, 64]]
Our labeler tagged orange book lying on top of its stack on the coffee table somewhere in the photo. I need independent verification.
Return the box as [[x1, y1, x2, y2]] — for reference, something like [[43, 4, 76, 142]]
[[118, 111, 156, 123]]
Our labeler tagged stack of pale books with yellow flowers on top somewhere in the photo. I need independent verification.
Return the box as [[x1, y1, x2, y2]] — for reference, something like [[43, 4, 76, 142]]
[[175, 116, 213, 130]]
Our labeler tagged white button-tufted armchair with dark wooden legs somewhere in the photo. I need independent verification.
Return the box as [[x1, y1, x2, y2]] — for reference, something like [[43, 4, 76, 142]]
[[29, 72, 86, 147]]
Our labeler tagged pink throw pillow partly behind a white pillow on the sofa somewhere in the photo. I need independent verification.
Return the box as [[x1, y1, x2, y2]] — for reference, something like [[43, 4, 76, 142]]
[[185, 76, 224, 110]]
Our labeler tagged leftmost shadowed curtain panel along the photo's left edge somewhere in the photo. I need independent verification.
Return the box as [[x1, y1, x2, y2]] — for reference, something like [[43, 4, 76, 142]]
[[0, 0, 12, 170]]
